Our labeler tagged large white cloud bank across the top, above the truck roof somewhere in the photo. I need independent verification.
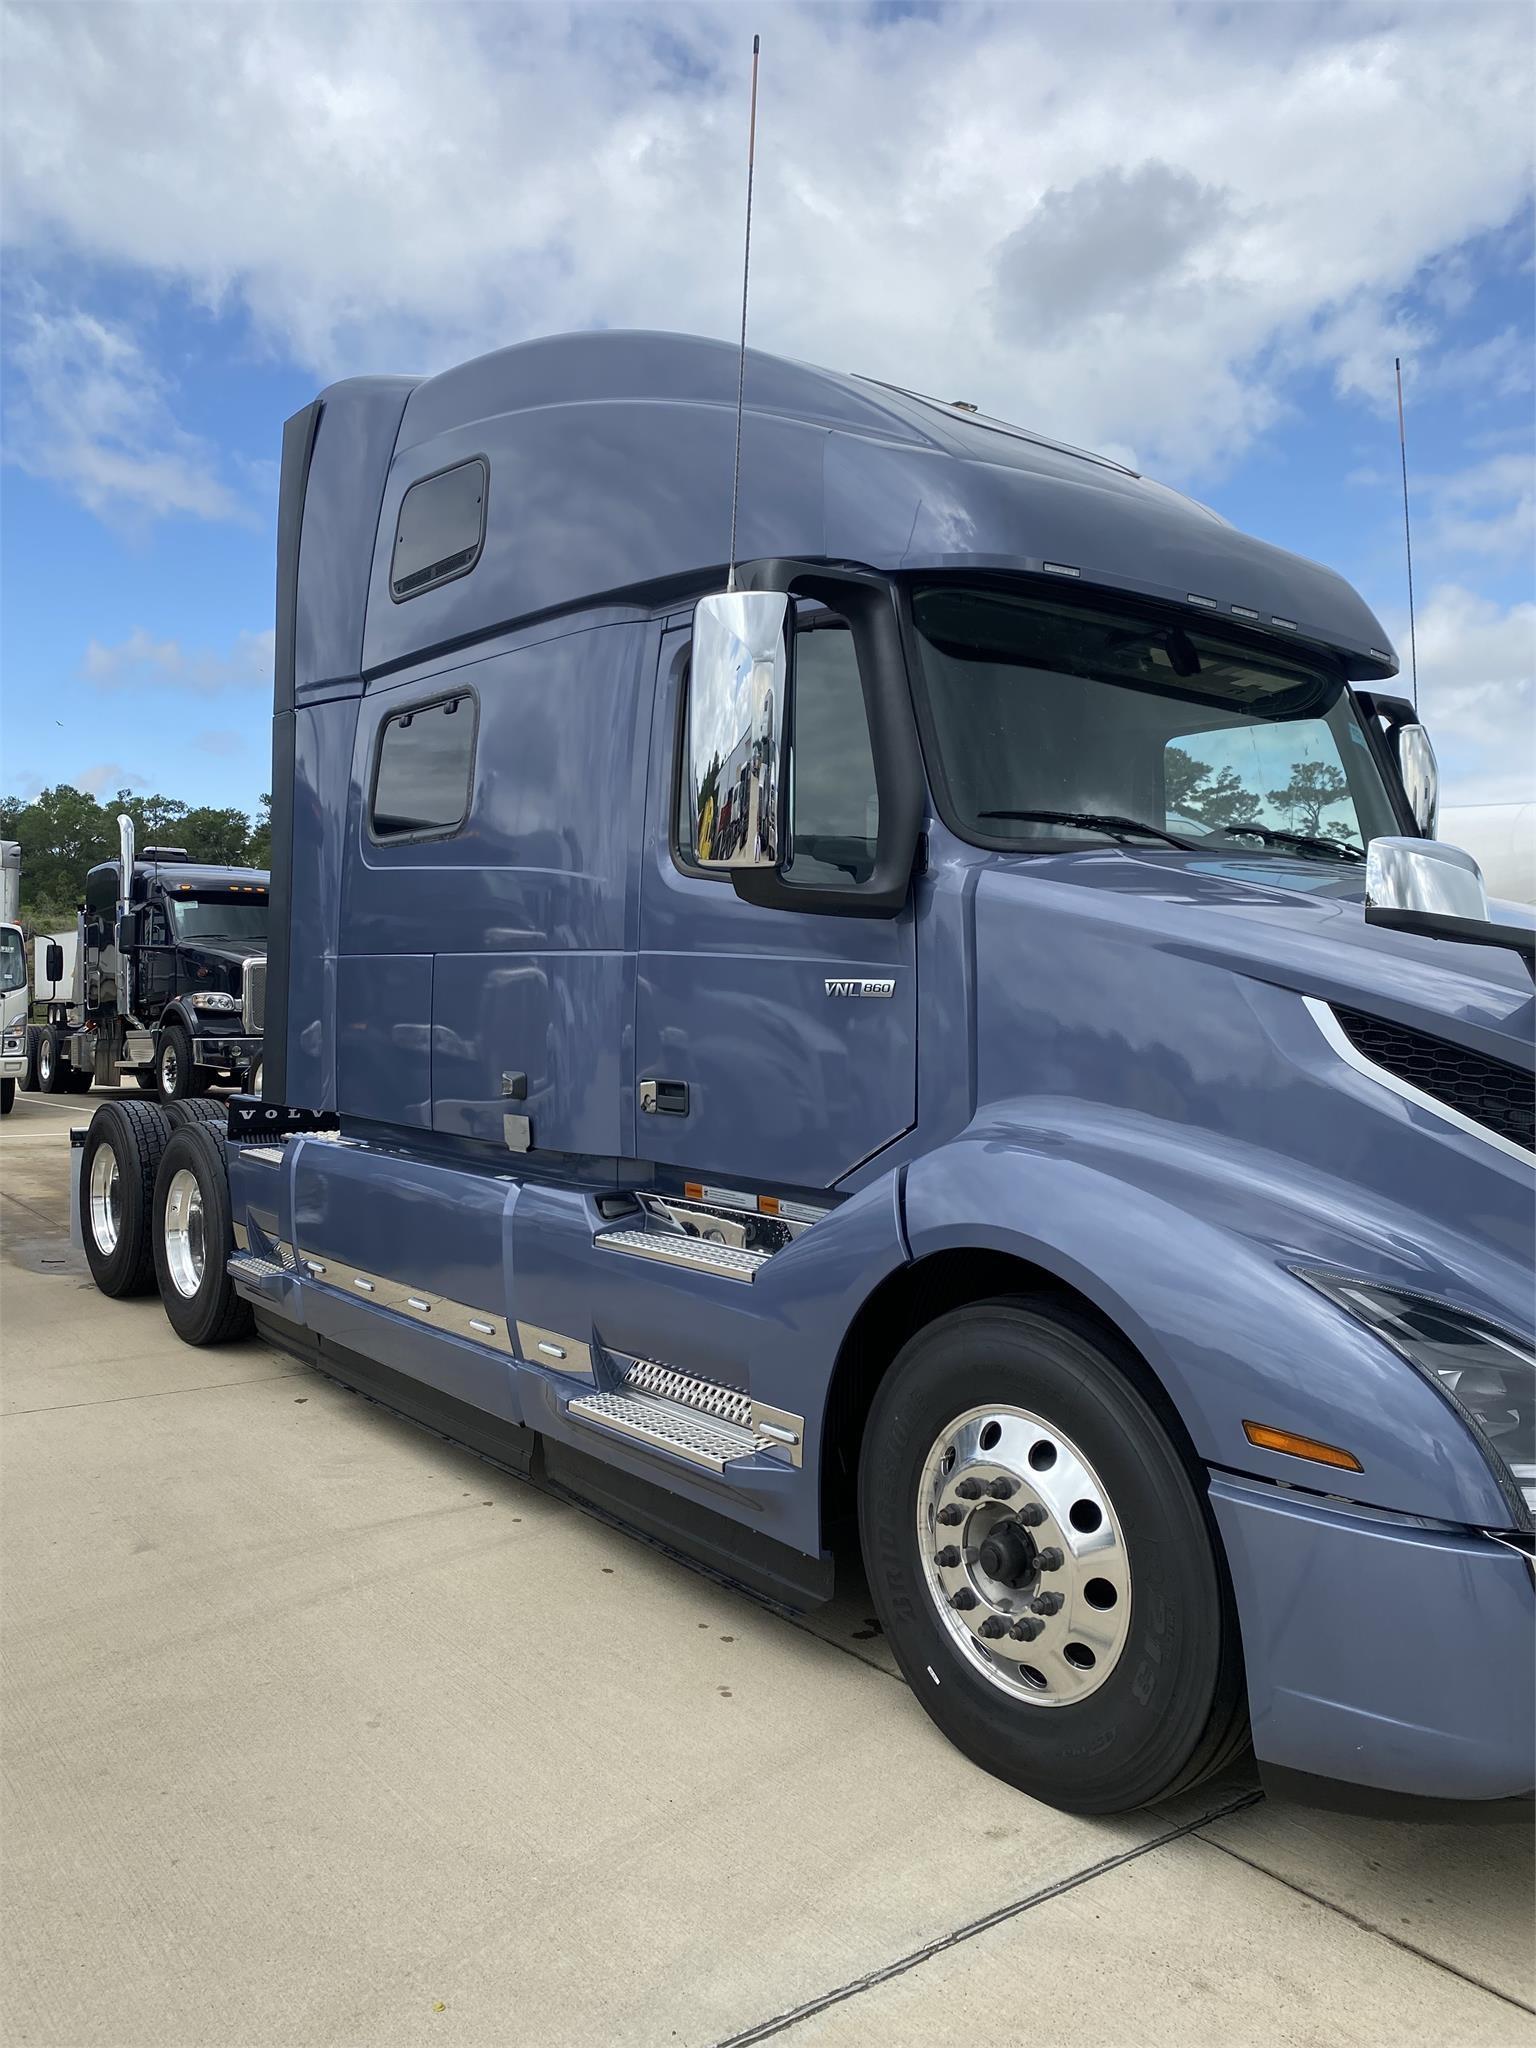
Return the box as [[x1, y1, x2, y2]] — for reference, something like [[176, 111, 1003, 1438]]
[[4, 0, 1532, 475]]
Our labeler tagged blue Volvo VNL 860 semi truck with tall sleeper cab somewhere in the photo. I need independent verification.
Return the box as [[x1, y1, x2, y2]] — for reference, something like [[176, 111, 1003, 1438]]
[[76, 334, 1536, 1815]]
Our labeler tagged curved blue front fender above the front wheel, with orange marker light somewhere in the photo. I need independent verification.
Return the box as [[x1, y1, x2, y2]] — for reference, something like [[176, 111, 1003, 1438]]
[[905, 1102, 1509, 1528]]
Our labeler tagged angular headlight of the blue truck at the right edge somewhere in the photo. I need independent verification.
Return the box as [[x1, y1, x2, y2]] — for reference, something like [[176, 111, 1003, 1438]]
[[1296, 1268, 1536, 1528]]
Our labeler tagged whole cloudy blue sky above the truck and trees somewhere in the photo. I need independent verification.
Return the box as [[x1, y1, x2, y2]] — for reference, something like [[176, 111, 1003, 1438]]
[[0, 0, 1536, 809]]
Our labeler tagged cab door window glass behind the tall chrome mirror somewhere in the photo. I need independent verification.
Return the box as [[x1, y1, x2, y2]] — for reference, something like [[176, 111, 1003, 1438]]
[[678, 616, 881, 887]]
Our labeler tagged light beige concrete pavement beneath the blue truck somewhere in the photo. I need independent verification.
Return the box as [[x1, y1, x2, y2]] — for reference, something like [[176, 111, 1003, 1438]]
[[0, 1096, 1536, 2048]]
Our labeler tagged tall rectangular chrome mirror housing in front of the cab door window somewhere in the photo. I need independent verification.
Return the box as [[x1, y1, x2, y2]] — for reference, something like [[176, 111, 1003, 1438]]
[[688, 590, 788, 870]]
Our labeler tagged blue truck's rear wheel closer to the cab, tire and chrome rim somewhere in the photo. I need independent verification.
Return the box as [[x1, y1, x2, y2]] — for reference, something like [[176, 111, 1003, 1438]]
[[152, 1122, 254, 1343]]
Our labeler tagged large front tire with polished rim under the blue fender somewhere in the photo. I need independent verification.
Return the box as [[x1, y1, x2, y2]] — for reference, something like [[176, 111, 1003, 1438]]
[[858, 1298, 1247, 1815]]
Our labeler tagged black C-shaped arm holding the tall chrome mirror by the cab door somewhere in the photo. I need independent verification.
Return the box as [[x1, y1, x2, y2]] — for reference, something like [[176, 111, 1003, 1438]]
[[731, 557, 924, 918]]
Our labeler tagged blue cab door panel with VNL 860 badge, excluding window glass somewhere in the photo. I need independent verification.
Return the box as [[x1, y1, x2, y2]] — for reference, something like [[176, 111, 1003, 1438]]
[[635, 610, 918, 1192]]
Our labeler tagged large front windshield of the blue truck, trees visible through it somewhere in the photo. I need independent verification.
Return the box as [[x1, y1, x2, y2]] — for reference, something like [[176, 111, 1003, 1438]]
[[913, 586, 1399, 862]]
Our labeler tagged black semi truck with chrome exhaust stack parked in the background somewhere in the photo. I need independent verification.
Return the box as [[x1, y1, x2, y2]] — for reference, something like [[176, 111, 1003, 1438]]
[[27, 817, 268, 1102]]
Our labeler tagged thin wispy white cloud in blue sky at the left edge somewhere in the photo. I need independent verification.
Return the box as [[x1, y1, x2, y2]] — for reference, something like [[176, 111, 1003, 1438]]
[[6, 303, 246, 520]]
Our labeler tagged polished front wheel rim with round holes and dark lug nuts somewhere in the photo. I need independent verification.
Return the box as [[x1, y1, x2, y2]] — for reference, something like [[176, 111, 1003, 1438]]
[[918, 1407, 1130, 1706]]
